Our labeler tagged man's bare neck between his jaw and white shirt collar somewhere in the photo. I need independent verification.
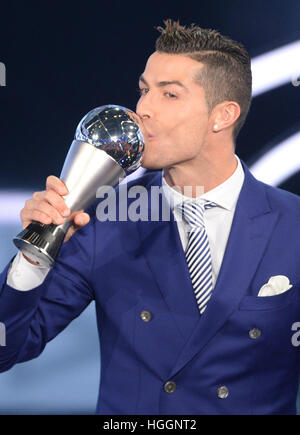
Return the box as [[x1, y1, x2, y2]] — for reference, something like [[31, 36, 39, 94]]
[[164, 153, 238, 198]]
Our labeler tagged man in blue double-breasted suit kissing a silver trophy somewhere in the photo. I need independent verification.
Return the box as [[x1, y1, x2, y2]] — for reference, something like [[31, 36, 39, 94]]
[[0, 21, 300, 414]]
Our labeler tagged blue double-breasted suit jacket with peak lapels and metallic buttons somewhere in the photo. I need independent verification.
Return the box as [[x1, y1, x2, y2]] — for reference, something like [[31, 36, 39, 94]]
[[0, 162, 300, 414]]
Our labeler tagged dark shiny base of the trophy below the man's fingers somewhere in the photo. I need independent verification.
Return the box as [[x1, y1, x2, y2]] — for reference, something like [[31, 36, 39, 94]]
[[13, 222, 65, 267]]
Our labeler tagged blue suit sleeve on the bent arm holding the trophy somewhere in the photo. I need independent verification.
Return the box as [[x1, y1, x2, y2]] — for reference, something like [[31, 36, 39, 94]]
[[0, 211, 95, 372]]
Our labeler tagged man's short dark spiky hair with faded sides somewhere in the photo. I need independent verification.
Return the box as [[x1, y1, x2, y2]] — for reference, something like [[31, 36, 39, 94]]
[[155, 19, 252, 139]]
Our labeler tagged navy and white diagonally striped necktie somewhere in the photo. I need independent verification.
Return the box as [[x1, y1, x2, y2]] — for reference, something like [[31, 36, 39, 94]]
[[179, 201, 217, 314]]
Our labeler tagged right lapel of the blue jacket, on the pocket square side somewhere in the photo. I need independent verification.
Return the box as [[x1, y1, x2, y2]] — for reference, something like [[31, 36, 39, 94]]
[[169, 162, 279, 378]]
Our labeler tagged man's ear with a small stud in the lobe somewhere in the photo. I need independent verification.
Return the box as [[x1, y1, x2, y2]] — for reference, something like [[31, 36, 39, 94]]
[[210, 101, 241, 133]]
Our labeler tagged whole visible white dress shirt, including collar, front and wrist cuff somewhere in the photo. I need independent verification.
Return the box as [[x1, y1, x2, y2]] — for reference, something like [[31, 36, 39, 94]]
[[7, 155, 245, 291]]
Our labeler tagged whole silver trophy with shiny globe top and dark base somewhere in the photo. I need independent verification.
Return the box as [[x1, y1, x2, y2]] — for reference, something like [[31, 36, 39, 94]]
[[14, 105, 144, 266]]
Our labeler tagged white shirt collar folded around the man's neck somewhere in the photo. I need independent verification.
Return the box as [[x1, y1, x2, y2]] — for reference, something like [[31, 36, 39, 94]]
[[162, 154, 245, 210]]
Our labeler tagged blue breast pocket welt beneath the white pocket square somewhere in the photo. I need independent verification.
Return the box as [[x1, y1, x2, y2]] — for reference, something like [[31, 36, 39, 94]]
[[239, 285, 300, 311]]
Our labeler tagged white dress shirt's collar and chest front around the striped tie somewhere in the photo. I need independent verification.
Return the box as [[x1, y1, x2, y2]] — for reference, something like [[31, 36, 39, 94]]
[[162, 155, 245, 287]]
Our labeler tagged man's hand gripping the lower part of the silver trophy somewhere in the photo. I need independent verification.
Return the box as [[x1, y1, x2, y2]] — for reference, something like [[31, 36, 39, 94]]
[[20, 175, 90, 264]]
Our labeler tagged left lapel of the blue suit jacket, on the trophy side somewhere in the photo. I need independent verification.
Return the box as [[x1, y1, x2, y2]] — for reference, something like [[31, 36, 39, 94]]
[[137, 173, 200, 343]]
